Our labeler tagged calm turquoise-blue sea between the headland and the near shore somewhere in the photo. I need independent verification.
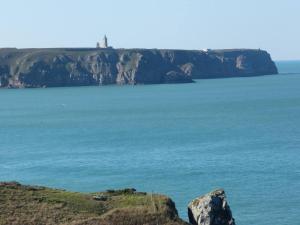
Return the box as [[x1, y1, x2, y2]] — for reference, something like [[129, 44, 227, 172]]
[[0, 61, 300, 225]]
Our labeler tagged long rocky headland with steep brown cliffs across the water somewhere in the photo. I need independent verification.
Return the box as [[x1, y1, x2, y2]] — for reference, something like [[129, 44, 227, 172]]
[[0, 49, 277, 88]]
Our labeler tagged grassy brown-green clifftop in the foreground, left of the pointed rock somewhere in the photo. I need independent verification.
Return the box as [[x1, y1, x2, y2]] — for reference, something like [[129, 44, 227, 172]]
[[0, 182, 187, 225]]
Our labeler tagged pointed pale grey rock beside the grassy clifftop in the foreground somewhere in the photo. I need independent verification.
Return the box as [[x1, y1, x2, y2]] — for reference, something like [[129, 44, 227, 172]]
[[188, 189, 235, 225]]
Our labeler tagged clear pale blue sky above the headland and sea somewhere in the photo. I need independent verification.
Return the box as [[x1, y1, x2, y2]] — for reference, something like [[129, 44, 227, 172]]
[[0, 0, 300, 60]]
